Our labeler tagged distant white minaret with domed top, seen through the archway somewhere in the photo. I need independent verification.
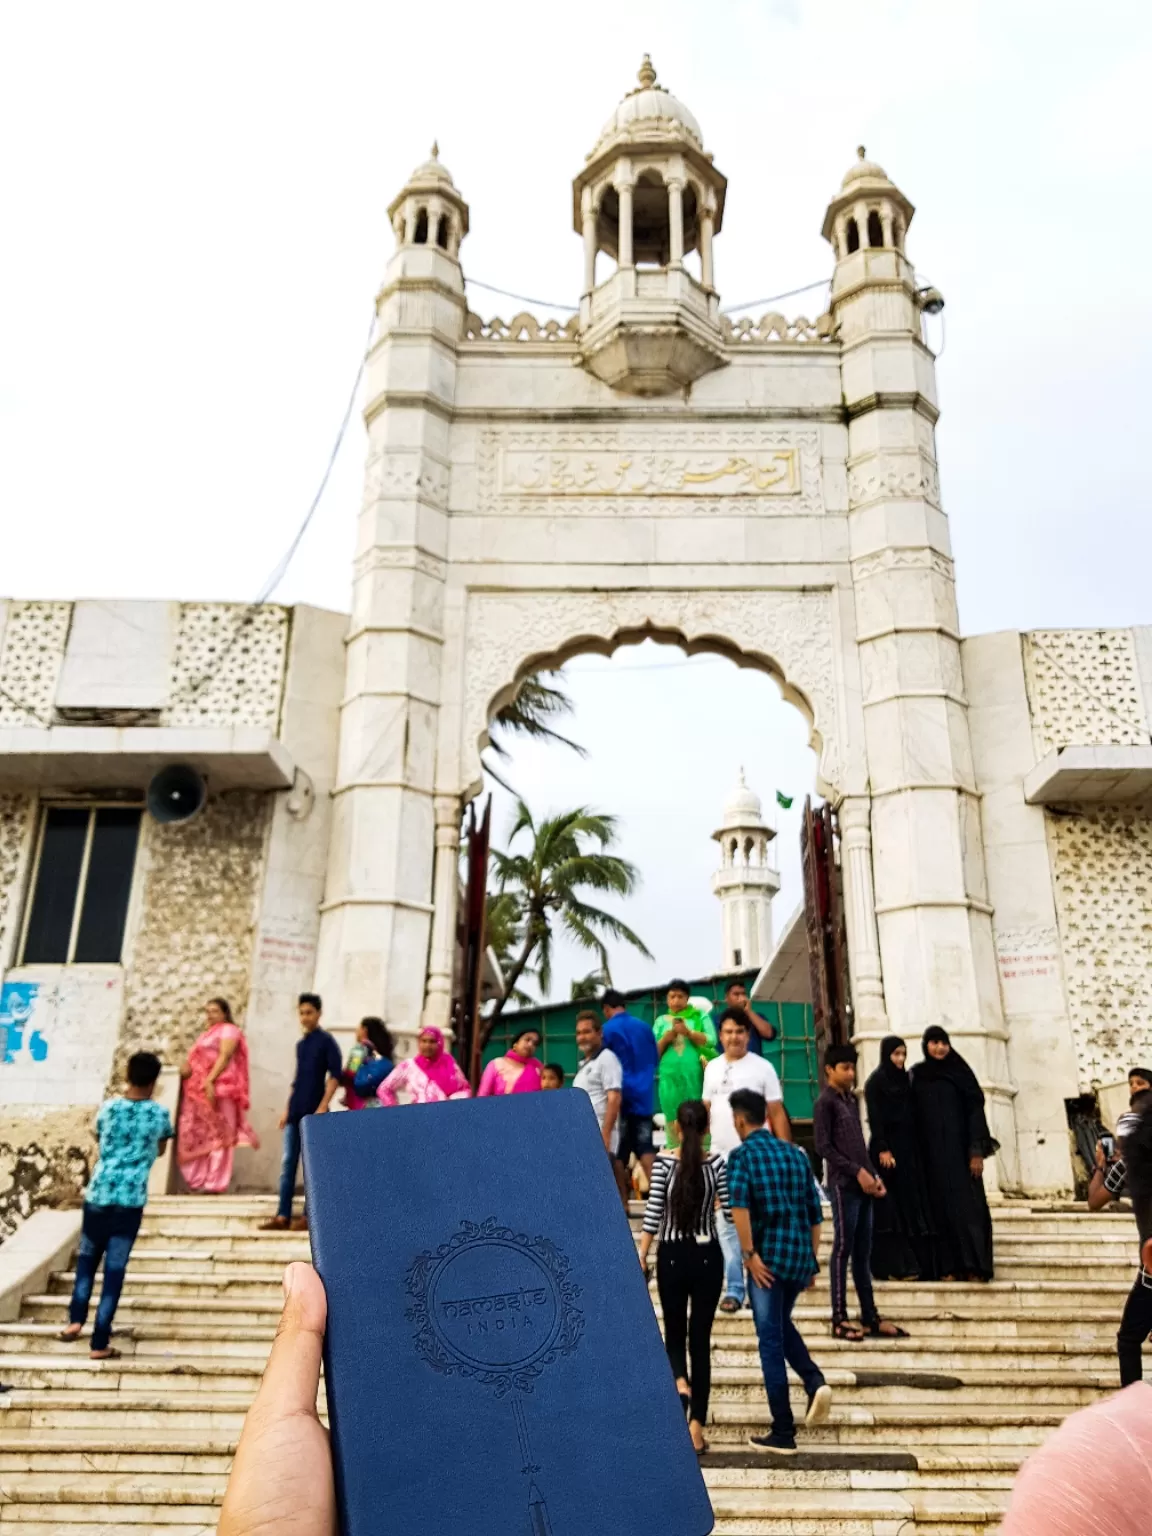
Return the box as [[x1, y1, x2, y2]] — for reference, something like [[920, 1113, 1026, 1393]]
[[713, 768, 780, 971]]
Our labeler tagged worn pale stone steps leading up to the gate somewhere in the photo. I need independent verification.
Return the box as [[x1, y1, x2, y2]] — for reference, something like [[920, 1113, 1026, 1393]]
[[0, 1197, 1135, 1536]]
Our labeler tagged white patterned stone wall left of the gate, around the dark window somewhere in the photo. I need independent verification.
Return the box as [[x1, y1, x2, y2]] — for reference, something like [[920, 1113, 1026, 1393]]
[[0, 602, 347, 1227]]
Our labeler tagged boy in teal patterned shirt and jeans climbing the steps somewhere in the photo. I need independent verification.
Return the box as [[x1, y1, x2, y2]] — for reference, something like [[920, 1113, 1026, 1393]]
[[60, 1051, 172, 1359]]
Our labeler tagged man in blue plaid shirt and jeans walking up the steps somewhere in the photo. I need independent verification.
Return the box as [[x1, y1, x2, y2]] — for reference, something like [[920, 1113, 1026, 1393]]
[[728, 1087, 833, 1456]]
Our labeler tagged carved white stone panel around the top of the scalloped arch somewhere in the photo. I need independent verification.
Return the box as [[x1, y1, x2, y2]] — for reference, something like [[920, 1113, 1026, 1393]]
[[464, 590, 839, 785]]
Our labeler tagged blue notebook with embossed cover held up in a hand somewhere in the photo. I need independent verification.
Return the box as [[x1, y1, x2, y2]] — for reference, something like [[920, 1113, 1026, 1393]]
[[303, 1091, 713, 1536]]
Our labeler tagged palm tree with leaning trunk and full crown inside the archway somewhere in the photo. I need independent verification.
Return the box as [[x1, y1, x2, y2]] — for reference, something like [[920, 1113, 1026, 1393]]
[[484, 800, 651, 1041]]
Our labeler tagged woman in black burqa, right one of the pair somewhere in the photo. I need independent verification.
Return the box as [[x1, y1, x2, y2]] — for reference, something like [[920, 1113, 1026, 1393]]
[[912, 1025, 1000, 1279]]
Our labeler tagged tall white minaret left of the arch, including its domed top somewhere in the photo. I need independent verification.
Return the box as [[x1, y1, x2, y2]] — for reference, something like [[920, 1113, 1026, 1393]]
[[316, 144, 468, 1051]]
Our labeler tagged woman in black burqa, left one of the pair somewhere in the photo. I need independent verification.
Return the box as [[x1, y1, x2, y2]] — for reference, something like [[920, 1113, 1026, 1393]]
[[865, 1035, 938, 1279]]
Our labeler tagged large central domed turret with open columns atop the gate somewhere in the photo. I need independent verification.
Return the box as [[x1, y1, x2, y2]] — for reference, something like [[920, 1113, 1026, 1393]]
[[573, 54, 727, 395]]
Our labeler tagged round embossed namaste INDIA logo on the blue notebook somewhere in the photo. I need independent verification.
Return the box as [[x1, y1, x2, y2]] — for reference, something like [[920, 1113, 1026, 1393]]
[[406, 1217, 584, 1398]]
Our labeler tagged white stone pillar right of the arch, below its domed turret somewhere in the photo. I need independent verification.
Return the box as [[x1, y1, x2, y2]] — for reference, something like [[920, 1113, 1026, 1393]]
[[833, 248, 1017, 1187]]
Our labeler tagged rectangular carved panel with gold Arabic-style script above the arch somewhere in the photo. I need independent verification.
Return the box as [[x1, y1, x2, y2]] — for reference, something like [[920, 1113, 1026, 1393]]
[[478, 424, 823, 516]]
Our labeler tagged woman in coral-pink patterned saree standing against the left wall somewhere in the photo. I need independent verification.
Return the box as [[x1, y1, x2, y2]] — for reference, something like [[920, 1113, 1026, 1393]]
[[177, 997, 260, 1195]]
